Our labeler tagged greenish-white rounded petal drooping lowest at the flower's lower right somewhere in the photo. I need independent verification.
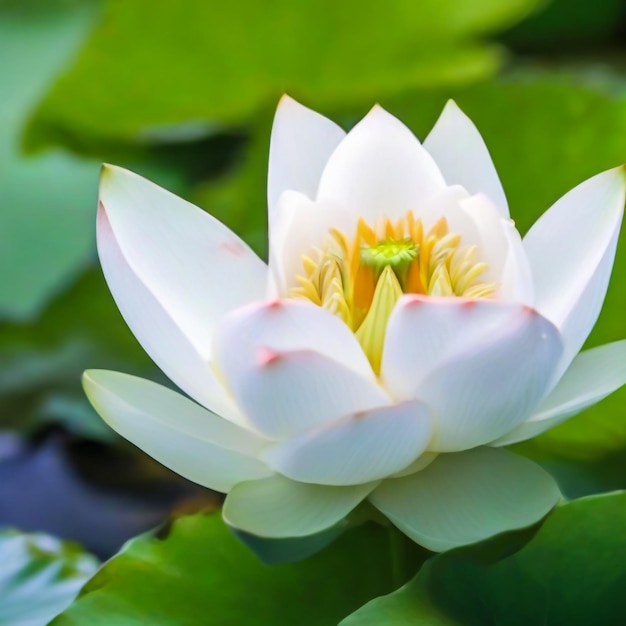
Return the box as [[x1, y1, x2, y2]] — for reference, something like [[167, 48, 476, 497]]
[[369, 448, 561, 551]]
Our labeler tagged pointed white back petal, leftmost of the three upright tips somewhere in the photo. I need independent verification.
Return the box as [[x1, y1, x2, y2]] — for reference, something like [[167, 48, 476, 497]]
[[267, 95, 346, 217]]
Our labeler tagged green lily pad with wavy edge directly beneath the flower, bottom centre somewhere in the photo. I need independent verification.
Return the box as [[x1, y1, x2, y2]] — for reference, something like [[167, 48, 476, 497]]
[[53, 513, 391, 626]]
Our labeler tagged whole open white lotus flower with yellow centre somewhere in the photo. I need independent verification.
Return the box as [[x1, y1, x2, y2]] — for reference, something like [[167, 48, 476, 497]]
[[84, 97, 626, 550]]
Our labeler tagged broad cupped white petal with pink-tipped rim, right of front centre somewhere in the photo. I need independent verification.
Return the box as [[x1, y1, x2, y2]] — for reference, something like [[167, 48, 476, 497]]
[[382, 296, 562, 452]]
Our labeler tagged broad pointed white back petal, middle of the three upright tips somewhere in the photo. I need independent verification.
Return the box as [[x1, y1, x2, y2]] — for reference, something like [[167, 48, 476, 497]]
[[317, 106, 445, 223]]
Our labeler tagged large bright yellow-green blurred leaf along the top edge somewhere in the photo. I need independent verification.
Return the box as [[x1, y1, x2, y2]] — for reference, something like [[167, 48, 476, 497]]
[[26, 0, 540, 146]]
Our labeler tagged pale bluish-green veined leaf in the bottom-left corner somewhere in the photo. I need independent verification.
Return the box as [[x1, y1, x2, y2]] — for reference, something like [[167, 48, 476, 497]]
[[0, 531, 98, 626]]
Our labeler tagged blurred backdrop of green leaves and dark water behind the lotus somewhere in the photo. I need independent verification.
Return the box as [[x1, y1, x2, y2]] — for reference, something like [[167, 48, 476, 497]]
[[0, 0, 626, 556]]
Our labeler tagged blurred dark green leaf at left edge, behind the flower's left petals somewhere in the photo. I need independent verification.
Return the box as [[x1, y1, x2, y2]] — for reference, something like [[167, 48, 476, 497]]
[[0, 270, 155, 440]]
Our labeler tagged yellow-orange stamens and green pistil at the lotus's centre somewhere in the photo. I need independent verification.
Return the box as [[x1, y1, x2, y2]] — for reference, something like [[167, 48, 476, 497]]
[[289, 211, 496, 374]]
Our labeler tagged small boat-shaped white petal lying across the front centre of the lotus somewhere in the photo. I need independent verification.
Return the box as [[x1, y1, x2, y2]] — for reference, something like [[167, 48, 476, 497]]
[[261, 402, 432, 485]]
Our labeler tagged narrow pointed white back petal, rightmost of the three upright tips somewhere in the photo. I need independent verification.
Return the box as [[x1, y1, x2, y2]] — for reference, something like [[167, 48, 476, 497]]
[[424, 100, 509, 217]]
